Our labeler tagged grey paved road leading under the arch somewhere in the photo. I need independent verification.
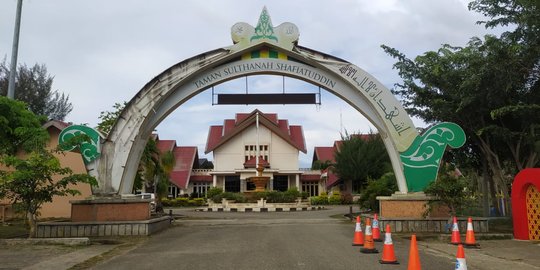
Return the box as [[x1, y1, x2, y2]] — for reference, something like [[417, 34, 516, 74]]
[[90, 208, 454, 270]]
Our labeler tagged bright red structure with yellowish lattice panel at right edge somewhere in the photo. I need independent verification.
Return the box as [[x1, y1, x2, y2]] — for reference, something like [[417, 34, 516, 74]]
[[512, 168, 540, 240]]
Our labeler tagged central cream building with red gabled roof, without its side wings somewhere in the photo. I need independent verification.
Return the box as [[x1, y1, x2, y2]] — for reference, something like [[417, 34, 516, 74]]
[[200, 110, 324, 195]]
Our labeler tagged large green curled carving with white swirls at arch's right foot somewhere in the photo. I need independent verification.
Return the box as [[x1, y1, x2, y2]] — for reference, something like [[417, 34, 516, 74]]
[[400, 122, 465, 192]]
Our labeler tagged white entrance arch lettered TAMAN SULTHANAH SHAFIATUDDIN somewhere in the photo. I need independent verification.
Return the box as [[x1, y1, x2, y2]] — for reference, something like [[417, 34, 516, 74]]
[[67, 9, 462, 194]]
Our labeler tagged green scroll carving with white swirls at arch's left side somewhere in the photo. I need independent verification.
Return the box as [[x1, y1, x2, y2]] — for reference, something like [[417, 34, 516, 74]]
[[58, 125, 100, 164]]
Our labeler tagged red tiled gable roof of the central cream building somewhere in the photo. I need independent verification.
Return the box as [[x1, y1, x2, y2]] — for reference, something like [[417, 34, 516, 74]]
[[205, 110, 307, 153]]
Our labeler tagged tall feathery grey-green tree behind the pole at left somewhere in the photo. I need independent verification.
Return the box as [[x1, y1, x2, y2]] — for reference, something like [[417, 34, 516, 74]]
[[0, 59, 73, 120]]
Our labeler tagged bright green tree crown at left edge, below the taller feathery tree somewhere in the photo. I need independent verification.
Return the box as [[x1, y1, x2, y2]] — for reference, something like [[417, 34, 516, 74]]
[[0, 96, 49, 156]]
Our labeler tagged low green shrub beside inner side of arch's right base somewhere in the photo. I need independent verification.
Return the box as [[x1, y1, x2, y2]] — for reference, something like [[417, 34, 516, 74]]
[[358, 172, 398, 211]]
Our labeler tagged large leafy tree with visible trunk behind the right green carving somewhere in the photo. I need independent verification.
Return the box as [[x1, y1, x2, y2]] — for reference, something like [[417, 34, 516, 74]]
[[383, 31, 540, 213]]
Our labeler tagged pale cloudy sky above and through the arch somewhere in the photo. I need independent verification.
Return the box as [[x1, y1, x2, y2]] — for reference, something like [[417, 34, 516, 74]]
[[0, 0, 498, 167]]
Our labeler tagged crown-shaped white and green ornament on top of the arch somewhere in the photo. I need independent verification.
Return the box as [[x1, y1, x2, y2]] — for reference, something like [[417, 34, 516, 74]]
[[228, 7, 300, 51]]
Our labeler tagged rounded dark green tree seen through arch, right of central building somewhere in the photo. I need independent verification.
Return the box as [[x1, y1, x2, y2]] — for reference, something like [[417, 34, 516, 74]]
[[333, 133, 390, 192]]
